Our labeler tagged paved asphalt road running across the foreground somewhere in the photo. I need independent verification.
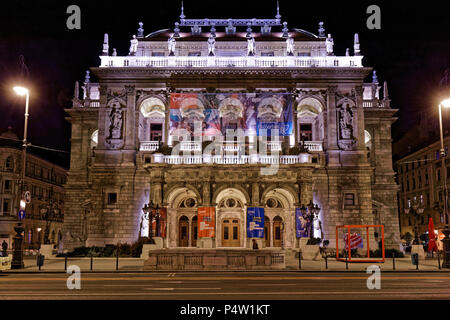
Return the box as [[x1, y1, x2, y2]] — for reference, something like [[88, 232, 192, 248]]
[[0, 272, 450, 300]]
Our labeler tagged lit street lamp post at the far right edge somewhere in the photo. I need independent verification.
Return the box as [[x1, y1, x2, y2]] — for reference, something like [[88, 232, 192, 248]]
[[439, 99, 450, 268]]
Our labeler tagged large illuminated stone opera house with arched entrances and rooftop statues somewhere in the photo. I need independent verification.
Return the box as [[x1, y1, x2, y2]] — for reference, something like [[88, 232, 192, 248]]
[[63, 7, 400, 250]]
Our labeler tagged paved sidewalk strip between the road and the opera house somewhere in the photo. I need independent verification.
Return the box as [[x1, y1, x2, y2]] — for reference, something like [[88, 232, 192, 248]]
[[3, 257, 450, 273]]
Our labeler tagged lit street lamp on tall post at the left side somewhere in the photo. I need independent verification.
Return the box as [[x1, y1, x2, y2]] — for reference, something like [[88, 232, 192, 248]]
[[11, 86, 30, 269]]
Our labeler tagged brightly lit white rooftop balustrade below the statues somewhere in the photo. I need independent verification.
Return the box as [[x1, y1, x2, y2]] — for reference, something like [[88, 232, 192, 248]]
[[100, 56, 363, 68]]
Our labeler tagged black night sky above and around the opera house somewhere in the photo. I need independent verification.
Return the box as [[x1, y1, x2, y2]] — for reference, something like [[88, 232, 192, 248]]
[[0, 0, 450, 166]]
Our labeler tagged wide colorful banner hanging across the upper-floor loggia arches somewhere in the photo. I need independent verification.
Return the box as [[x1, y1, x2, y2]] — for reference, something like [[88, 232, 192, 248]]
[[169, 93, 293, 137]]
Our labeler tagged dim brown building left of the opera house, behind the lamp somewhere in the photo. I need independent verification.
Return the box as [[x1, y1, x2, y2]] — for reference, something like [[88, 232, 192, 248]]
[[0, 129, 67, 249]]
